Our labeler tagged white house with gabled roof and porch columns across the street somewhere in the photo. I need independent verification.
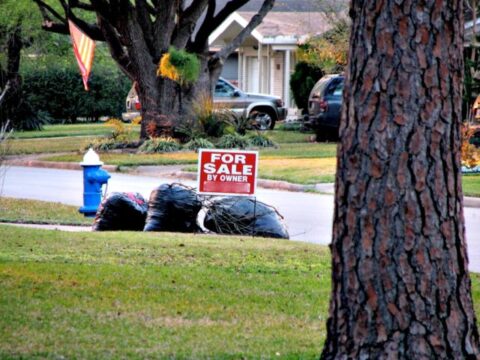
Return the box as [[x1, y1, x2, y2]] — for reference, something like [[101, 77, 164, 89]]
[[209, 11, 338, 107]]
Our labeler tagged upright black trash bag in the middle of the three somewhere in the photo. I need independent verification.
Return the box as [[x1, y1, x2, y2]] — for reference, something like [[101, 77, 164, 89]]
[[143, 184, 202, 232]]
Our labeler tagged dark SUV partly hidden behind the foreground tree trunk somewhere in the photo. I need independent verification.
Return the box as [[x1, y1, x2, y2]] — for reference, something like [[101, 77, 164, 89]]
[[306, 75, 345, 140]]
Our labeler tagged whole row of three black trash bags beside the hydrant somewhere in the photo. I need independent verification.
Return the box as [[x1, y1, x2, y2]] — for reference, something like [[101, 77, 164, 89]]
[[93, 183, 289, 239]]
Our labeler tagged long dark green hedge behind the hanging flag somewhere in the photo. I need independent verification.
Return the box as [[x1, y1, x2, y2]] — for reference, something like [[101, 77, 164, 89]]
[[22, 66, 131, 122]]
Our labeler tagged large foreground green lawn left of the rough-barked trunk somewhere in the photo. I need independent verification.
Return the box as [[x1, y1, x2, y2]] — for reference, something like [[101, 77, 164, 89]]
[[0, 226, 330, 359]]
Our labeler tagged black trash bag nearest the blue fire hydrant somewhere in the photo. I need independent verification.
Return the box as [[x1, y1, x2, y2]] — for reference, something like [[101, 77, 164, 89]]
[[93, 192, 148, 231]]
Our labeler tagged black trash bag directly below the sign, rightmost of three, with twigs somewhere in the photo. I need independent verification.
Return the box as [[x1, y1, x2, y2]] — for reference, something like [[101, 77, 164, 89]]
[[204, 197, 289, 239]]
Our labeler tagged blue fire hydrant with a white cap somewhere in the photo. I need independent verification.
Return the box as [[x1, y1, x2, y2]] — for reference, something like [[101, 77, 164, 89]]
[[78, 148, 110, 217]]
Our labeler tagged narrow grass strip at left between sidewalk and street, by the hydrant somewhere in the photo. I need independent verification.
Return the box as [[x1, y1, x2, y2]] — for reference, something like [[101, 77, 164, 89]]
[[0, 197, 93, 225]]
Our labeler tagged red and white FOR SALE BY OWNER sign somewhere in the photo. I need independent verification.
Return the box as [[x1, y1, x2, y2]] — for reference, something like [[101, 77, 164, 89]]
[[198, 149, 258, 196]]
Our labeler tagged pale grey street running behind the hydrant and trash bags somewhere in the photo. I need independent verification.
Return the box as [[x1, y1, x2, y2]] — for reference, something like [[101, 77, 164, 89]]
[[0, 166, 480, 272]]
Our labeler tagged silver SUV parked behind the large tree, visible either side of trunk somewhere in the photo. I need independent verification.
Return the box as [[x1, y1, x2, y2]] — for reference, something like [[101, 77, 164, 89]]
[[122, 78, 287, 130]]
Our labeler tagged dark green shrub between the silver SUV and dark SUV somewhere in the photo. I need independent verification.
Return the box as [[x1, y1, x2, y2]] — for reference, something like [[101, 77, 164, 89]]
[[290, 61, 324, 114]]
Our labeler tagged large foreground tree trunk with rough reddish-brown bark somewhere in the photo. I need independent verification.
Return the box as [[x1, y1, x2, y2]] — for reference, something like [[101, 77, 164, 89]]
[[322, 0, 480, 359]]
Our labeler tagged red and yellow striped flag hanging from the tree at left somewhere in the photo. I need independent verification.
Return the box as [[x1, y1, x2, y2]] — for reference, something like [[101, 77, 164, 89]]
[[68, 20, 95, 91]]
